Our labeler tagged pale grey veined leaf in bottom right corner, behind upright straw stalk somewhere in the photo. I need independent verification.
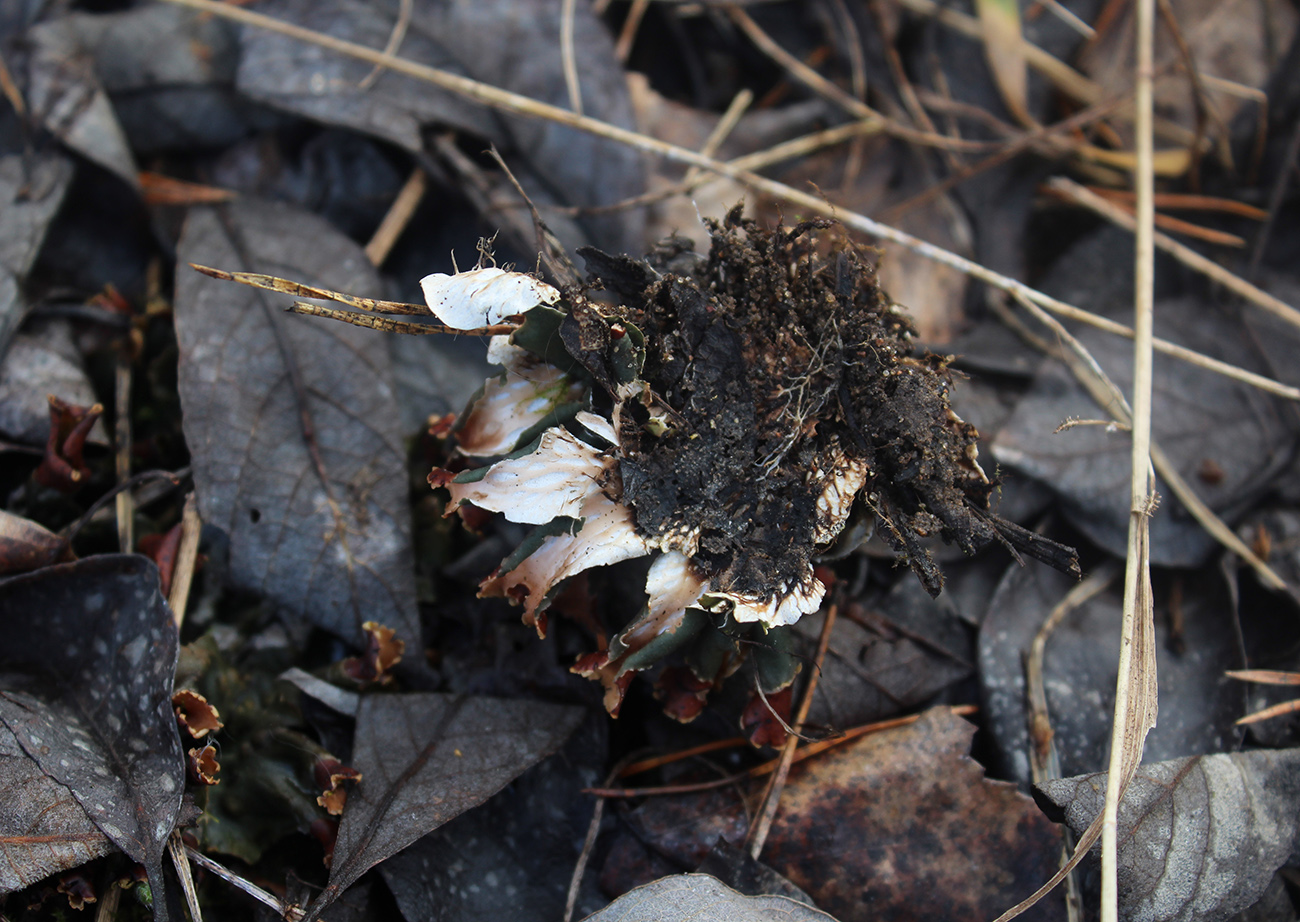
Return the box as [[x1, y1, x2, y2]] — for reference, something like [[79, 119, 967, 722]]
[[1039, 749, 1300, 922]]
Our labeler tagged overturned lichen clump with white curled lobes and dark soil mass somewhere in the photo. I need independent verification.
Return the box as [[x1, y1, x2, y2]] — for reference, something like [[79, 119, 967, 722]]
[[430, 211, 1076, 711]]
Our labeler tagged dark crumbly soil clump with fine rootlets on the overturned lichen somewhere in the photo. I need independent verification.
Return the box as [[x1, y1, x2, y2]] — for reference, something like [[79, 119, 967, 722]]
[[575, 213, 992, 598]]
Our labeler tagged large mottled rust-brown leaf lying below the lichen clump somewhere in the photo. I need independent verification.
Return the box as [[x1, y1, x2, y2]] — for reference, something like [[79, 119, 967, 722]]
[[603, 709, 1061, 922]]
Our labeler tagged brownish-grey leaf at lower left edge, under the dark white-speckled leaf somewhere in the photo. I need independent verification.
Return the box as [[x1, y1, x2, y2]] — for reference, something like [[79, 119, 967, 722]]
[[0, 724, 113, 893]]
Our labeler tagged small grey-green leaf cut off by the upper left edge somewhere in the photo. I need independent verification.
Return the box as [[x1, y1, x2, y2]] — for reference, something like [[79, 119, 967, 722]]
[[0, 155, 73, 359]]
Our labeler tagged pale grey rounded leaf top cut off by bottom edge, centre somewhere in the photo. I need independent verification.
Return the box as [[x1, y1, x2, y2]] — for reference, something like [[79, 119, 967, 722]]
[[585, 874, 835, 922]]
